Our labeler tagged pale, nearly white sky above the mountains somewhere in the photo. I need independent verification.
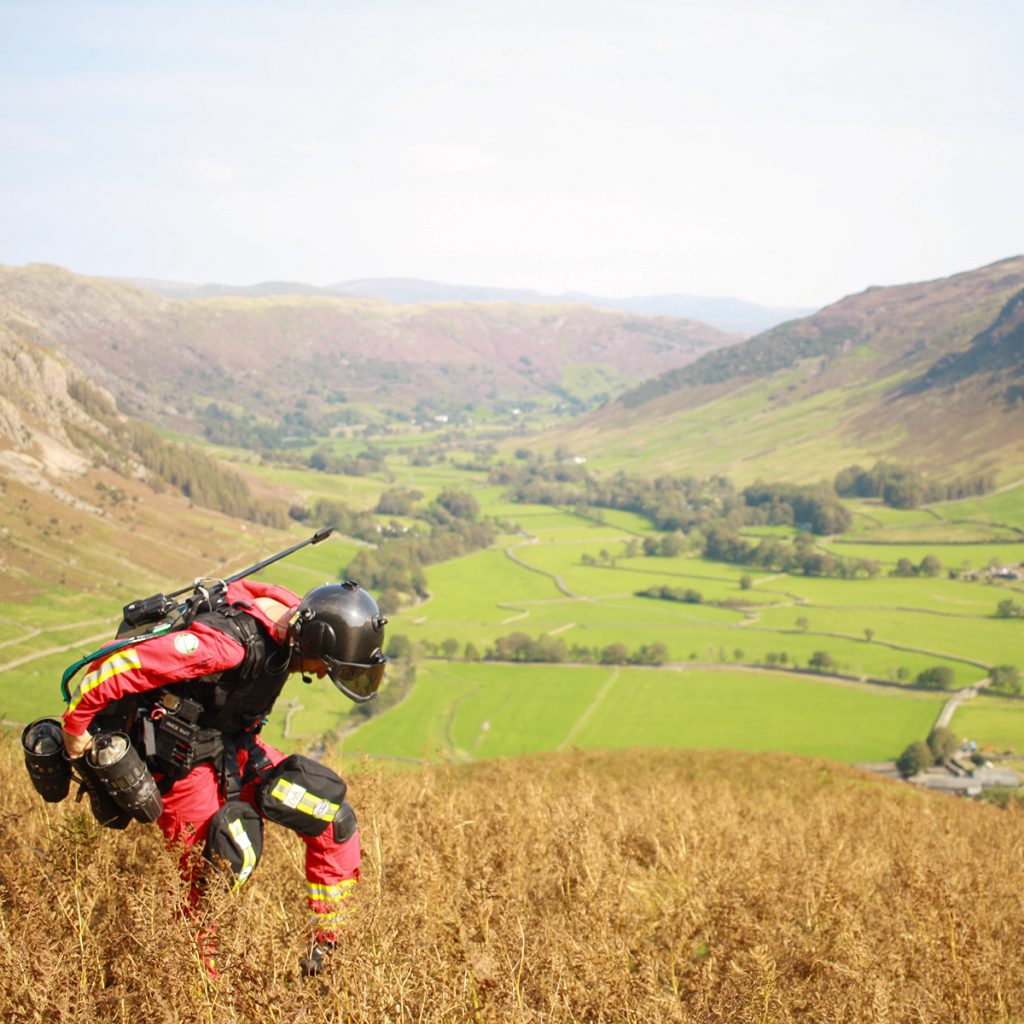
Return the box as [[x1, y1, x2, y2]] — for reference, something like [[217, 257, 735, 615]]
[[0, 0, 1024, 307]]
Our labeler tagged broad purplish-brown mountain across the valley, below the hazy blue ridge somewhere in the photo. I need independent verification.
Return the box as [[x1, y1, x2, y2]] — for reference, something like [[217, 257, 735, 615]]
[[0, 265, 736, 434]]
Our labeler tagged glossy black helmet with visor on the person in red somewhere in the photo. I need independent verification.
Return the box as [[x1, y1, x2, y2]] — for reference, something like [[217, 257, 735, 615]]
[[289, 580, 387, 703]]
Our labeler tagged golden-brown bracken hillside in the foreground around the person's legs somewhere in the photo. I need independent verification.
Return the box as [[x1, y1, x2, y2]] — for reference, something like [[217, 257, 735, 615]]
[[0, 740, 1024, 1024]]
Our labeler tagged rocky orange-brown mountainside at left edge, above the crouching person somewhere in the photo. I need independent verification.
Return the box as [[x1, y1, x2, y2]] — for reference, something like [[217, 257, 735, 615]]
[[0, 311, 287, 598]]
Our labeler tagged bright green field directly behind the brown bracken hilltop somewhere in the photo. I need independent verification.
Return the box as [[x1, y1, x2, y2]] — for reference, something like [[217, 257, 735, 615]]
[[343, 664, 942, 762]]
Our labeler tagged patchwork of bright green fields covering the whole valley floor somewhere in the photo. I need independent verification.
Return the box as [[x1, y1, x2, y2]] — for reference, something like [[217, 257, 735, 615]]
[[0, 438, 1024, 761]]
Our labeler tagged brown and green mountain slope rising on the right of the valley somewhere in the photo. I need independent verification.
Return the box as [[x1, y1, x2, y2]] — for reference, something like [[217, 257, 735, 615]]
[[551, 256, 1024, 480]]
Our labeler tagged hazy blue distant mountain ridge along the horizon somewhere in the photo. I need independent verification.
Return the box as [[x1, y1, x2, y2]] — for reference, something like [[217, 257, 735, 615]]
[[131, 278, 813, 335]]
